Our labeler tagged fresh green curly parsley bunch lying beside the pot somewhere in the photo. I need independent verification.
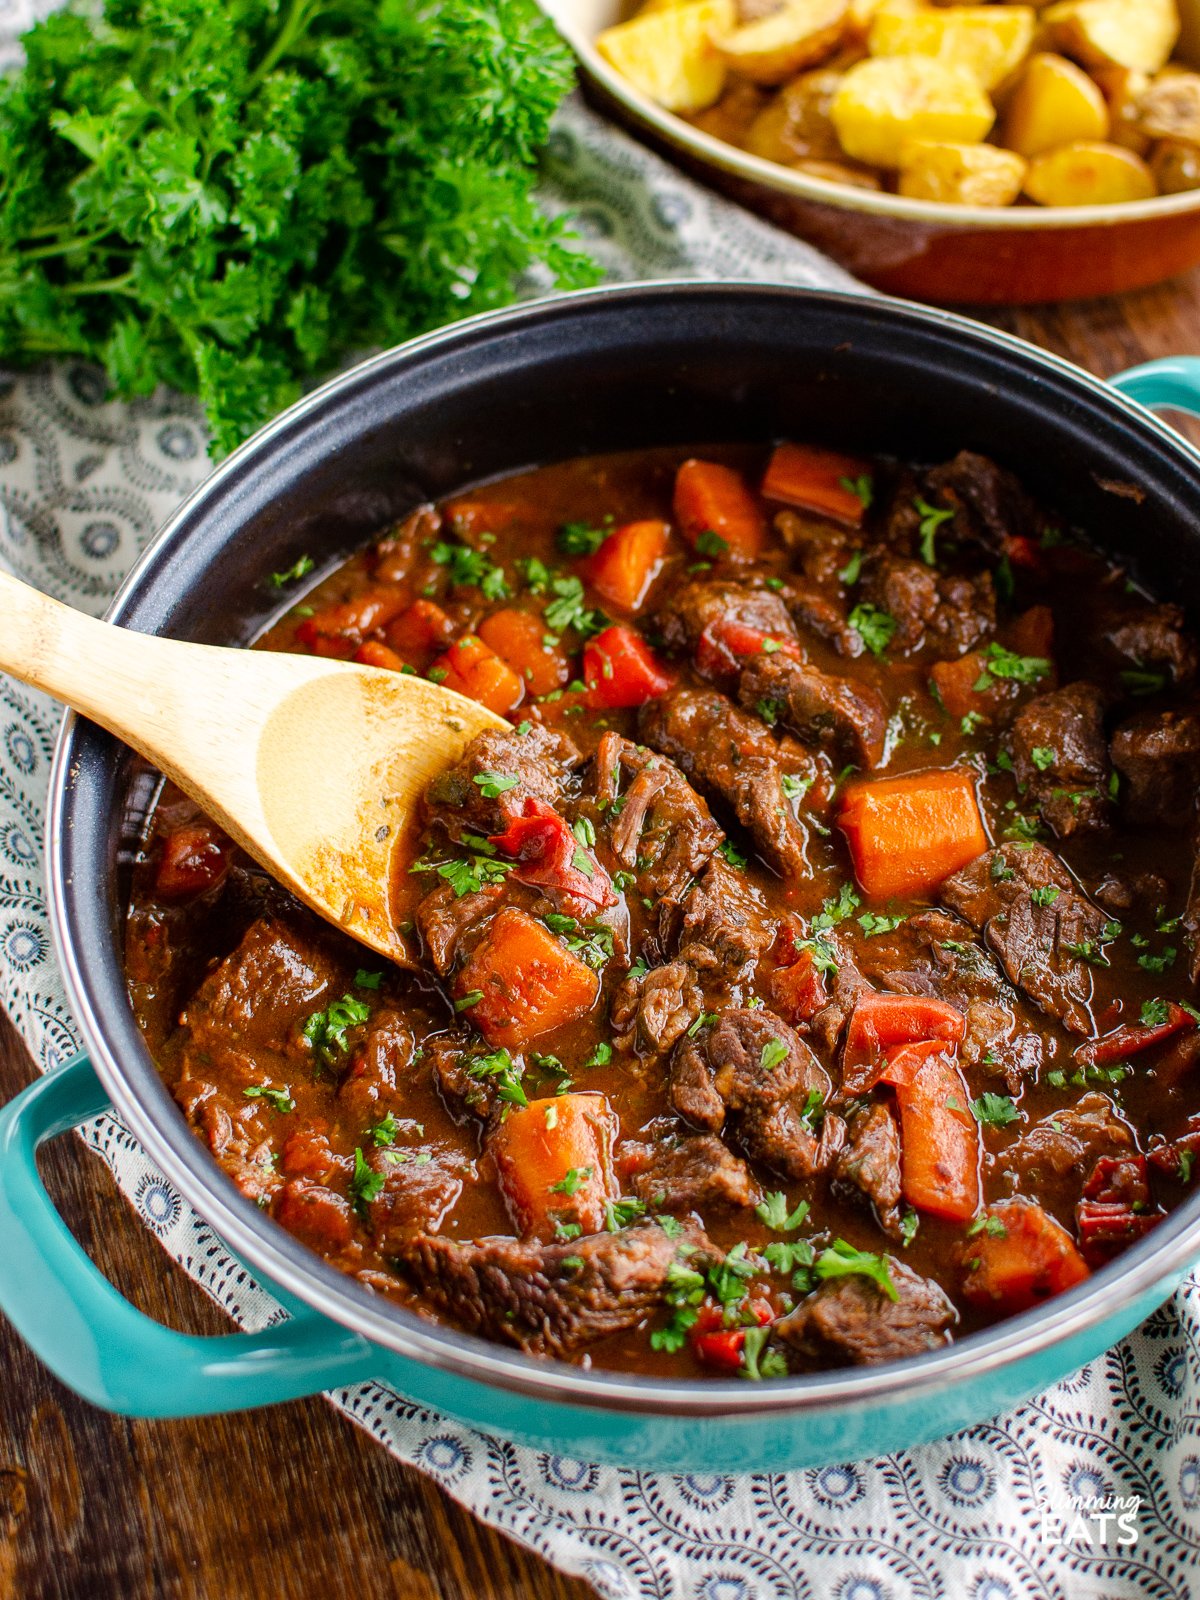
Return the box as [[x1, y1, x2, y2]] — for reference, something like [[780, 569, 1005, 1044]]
[[0, 0, 594, 454]]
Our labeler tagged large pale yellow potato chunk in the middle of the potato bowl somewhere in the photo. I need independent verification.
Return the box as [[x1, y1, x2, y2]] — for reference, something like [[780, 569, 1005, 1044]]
[[829, 56, 995, 168]]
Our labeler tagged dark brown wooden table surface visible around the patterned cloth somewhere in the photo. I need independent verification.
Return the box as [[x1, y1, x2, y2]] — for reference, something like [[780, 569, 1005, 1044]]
[[0, 270, 1200, 1600]]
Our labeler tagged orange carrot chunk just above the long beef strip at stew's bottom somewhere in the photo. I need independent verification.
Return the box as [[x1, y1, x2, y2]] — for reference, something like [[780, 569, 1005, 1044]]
[[488, 1094, 619, 1238]]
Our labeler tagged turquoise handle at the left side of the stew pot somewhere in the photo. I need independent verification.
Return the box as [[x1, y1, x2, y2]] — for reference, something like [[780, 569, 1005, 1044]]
[[0, 1056, 381, 1418]]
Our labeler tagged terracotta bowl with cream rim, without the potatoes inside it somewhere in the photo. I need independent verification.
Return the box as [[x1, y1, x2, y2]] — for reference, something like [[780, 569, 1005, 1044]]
[[553, 0, 1200, 306]]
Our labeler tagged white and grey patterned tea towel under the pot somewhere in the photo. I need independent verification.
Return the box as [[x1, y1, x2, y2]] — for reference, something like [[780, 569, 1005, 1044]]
[[0, 0, 1200, 1600]]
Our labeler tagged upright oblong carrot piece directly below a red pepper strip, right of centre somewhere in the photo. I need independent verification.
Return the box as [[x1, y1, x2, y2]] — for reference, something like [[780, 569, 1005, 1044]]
[[896, 1046, 979, 1222]]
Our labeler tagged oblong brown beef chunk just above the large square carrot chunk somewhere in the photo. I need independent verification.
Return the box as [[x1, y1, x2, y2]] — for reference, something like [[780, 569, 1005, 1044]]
[[738, 651, 888, 770]]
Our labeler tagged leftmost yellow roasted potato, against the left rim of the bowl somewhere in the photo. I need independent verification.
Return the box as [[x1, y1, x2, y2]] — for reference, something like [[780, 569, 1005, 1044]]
[[595, 0, 736, 112]]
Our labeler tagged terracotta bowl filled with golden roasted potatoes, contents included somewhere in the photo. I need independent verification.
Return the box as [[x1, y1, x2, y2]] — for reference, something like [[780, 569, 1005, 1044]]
[[542, 0, 1200, 306]]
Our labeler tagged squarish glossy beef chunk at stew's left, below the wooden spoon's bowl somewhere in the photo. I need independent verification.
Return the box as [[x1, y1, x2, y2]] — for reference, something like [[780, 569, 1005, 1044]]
[[181, 910, 342, 1058]]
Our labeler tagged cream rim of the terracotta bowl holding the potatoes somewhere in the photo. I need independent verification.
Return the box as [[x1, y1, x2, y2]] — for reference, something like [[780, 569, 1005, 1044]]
[[538, 0, 1200, 234]]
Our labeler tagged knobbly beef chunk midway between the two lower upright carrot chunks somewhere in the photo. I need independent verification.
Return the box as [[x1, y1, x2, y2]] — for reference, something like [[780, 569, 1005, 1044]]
[[669, 1010, 829, 1171]]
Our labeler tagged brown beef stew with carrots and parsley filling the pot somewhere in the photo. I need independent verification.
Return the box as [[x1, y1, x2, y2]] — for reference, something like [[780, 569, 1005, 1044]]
[[126, 443, 1200, 1379]]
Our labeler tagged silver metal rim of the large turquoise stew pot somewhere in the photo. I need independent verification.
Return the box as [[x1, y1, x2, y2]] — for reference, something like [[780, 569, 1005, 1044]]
[[46, 278, 1200, 1419]]
